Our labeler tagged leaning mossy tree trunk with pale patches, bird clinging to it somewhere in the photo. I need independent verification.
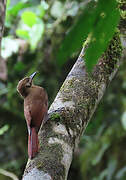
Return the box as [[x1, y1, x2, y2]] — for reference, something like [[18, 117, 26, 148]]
[[23, 1, 126, 180]]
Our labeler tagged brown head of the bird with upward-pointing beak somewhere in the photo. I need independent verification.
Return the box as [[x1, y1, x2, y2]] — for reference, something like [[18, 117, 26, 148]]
[[17, 72, 36, 98]]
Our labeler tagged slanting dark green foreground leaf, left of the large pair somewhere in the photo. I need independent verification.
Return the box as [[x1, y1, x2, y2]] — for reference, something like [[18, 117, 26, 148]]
[[57, 1, 95, 66]]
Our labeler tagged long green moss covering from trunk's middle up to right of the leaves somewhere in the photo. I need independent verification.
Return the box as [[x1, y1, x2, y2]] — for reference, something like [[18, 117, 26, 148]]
[[55, 32, 122, 141]]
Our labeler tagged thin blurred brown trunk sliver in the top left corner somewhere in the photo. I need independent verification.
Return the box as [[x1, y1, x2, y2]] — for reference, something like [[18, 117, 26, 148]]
[[0, 0, 6, 53]]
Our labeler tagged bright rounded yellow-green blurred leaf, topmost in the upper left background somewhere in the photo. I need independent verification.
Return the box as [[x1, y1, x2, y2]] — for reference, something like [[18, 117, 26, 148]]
[[21, 11, 37, 27]]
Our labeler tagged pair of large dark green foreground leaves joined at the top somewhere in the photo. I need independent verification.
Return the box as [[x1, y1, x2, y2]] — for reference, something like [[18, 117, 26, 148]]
[[57, 0, 119, 71]]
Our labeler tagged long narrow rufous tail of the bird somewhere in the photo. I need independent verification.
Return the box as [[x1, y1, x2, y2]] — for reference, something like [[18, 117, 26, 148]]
[[28, 127, 38, 159]]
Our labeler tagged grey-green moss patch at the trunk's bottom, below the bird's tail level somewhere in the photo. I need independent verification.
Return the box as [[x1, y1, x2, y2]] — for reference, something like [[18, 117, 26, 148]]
[[36, 143, 65, 180]]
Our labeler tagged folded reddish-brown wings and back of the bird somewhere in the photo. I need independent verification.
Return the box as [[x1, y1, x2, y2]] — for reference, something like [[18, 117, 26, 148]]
[[24, 89, 48, 131]]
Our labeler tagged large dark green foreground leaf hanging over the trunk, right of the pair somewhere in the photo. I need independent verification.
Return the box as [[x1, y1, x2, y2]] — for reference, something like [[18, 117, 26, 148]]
[[85, 0, 119, 72]]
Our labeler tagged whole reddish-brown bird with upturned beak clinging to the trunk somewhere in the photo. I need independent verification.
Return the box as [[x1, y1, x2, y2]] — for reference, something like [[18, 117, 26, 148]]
[[17, 72, 48, 159]]
